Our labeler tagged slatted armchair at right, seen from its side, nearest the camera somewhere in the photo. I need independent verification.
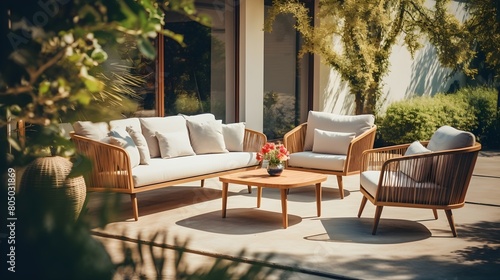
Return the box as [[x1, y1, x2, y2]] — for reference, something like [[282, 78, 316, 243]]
[[358, 131, 481, 237]]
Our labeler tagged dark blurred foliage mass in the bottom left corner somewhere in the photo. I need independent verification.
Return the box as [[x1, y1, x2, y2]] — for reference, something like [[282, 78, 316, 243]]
[[1, 189, 115, 280]]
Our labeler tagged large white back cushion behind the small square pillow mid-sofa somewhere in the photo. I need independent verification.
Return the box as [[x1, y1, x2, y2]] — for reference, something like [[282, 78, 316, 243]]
[[139, 116, 188, 158]]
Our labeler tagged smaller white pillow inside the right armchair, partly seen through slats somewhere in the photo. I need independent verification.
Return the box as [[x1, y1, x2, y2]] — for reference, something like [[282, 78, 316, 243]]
[[399, 141, 432, 182]]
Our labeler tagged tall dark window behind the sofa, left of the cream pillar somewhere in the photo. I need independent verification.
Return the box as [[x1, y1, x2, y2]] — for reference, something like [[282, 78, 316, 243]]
[[159, 0, 234, 120]]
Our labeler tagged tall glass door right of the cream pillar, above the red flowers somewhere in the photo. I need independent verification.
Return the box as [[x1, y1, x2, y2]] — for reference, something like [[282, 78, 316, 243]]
[[264, 2, 309, 140]]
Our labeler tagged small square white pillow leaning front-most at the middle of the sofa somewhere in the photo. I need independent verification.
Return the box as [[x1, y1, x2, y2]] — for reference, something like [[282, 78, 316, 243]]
[[156, 131, 195, 158]]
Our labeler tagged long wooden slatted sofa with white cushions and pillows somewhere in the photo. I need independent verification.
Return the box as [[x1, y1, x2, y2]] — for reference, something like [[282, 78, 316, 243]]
[[70, 114, 267, 221]]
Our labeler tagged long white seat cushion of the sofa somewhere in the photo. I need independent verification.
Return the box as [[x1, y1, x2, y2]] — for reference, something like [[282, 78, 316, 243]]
[[132, 152, 258, 187]]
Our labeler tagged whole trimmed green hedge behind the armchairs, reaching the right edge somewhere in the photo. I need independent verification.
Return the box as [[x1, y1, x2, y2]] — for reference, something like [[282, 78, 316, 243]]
[[377, 87, 499, 148]]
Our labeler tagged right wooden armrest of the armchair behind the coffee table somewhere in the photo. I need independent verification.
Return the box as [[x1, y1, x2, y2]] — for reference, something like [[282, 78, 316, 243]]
[[345, 125, 377, 173]]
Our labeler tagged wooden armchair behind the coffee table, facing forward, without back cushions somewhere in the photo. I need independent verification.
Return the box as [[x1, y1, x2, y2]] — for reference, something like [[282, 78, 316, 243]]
[[283, 111, 377, 199]]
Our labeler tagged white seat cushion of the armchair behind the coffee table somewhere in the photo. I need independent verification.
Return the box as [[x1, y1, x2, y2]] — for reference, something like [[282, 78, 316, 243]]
[[288, 152, 346, 171]]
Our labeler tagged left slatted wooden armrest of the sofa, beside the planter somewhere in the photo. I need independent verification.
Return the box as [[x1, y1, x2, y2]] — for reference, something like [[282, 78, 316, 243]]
[[70, 132, 134, 192]]
